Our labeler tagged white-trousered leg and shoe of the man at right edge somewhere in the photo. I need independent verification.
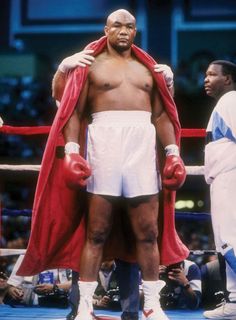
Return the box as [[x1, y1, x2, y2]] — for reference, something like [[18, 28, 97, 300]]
[[203, 174, 236, 320]]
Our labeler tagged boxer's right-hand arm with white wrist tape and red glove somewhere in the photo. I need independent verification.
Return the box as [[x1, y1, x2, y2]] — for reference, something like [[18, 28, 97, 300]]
[[152, 90, 186, 190]]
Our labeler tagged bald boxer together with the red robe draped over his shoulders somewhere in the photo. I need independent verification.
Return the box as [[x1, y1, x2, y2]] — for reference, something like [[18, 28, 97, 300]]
[[19, 9, 188, 320]]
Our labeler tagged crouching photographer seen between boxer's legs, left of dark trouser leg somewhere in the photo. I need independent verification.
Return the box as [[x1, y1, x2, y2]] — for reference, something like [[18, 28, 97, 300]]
[[93, 260, 121, 310]]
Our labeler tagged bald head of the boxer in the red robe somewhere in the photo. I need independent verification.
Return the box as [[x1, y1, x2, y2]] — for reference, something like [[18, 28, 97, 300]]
[[104, 9, 136, 52]]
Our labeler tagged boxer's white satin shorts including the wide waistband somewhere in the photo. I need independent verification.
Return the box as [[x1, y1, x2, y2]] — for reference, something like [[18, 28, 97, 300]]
[[87, 111, 161, 198]]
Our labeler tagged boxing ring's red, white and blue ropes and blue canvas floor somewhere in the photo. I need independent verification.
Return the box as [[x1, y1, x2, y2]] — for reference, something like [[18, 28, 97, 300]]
[[0, 125, 212, 320]]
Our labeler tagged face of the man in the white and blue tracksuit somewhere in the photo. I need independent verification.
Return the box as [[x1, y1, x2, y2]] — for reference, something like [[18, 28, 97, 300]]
[[204, 64, 227, 98]]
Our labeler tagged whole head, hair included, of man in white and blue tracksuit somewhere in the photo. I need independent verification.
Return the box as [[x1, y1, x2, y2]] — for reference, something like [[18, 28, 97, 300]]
[[204, 60, 236, 99]]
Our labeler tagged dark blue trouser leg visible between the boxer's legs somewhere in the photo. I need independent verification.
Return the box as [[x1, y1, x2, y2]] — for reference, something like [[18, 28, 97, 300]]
[[116, 260, 139, 320]]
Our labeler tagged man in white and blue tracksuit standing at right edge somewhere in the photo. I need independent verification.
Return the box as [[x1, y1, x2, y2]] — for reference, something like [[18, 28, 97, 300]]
[[204, 60, 236, 319]]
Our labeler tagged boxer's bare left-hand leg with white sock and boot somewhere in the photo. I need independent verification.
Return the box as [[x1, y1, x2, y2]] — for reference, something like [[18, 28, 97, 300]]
[[75, 195, 112, 320]]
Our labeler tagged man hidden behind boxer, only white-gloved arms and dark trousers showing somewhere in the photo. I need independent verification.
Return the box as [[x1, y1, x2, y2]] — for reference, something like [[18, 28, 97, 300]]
[[52, 50, 174, 320]]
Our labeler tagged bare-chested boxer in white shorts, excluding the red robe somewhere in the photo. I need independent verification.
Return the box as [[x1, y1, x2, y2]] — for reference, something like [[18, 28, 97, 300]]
[[64, 10, 184, 320]]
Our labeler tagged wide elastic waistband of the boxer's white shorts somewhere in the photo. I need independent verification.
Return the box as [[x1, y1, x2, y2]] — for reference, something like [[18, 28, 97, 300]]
[[92, 110, 151, 125]]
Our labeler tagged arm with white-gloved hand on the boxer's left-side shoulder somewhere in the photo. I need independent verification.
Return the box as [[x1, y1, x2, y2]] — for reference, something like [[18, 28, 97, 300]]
[[52, 50, 94, 105]]
